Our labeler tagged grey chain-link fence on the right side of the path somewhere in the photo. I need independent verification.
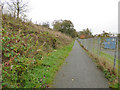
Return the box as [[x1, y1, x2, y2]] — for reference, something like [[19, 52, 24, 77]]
[[78, 37, 118, 71]]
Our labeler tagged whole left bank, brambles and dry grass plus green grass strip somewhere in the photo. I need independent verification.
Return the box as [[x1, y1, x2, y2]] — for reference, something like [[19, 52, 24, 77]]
[[0, 15, 73, 88]]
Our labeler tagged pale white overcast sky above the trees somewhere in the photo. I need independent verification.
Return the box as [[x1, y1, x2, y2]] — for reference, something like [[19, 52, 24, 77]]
[[21, 0, 120, 34]]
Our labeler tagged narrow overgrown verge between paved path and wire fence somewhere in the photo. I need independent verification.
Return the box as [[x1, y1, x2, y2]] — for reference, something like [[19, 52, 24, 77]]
[[78, 41, 118, 88]]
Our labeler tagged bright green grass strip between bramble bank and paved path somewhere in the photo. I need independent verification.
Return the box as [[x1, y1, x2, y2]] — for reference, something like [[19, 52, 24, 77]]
[[24, 42, 74, 88]]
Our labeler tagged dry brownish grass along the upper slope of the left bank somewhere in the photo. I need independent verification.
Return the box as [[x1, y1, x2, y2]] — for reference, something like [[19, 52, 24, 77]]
[[2, 15, 73, 51]]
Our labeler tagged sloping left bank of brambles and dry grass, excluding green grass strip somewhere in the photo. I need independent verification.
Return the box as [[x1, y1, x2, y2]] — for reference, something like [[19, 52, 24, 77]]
[[2, 15, 73, 88]]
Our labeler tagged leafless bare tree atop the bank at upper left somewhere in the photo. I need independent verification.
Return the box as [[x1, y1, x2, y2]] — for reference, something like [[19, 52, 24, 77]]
[[7, 0, 28, 18]]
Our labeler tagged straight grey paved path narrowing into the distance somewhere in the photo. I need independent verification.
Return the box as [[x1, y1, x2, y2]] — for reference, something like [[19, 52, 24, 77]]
[[53, 41, 108, 88]]
